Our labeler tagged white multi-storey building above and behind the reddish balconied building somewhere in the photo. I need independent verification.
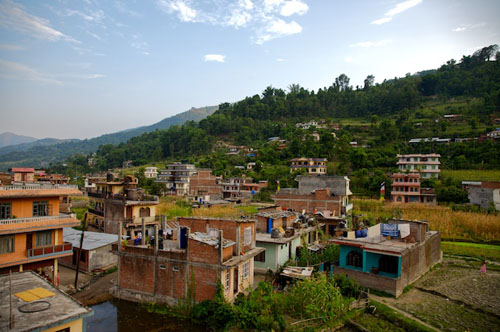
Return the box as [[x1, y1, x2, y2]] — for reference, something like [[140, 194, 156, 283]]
[[397, 153, 441, 179]]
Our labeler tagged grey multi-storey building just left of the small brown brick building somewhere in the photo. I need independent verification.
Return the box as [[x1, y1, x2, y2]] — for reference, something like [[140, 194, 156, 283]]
[[156, 162, 196, 196]]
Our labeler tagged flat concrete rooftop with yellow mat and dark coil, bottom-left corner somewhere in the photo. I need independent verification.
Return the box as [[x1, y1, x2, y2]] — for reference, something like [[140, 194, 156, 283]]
[[0, 271, 94, 331]]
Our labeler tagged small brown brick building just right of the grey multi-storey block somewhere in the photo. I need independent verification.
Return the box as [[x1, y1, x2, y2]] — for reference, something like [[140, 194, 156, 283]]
[[189, 168, 222, 204]]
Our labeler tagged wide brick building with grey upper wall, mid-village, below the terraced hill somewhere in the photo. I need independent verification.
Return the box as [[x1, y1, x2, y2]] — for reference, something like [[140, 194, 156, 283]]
[[271, 175, 352, 216]]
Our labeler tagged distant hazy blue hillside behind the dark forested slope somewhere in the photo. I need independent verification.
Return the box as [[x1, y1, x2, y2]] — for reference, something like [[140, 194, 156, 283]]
[[0, 106, 217, 170]]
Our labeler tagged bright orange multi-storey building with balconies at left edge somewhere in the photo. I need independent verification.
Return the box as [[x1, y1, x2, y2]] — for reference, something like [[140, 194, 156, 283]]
[[0, 184, 81, 284]]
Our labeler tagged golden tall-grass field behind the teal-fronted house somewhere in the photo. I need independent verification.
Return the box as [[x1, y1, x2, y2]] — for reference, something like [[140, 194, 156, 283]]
[[353, 199, 500, 243]]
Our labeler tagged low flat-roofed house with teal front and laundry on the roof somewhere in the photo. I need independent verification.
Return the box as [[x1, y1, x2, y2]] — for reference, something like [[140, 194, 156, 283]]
[[330, 220, 442, 297]]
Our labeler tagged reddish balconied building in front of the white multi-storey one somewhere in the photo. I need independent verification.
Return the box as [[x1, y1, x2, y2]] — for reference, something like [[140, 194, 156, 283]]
[[391, 173, 437, 205]]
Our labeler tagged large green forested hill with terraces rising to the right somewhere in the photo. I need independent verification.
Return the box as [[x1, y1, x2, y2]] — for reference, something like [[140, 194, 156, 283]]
[[55, 45, 500, 195]]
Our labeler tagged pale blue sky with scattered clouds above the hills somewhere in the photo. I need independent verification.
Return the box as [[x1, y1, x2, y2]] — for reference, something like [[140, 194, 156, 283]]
[[0, 0, 500, 138]]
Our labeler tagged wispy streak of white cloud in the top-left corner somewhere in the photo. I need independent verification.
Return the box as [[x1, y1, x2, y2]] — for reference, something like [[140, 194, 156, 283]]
[[0, 0, 80, 43]]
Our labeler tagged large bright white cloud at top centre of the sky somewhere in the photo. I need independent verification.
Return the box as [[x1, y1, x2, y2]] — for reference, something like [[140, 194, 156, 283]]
[[156, 0, 309, 44]]
